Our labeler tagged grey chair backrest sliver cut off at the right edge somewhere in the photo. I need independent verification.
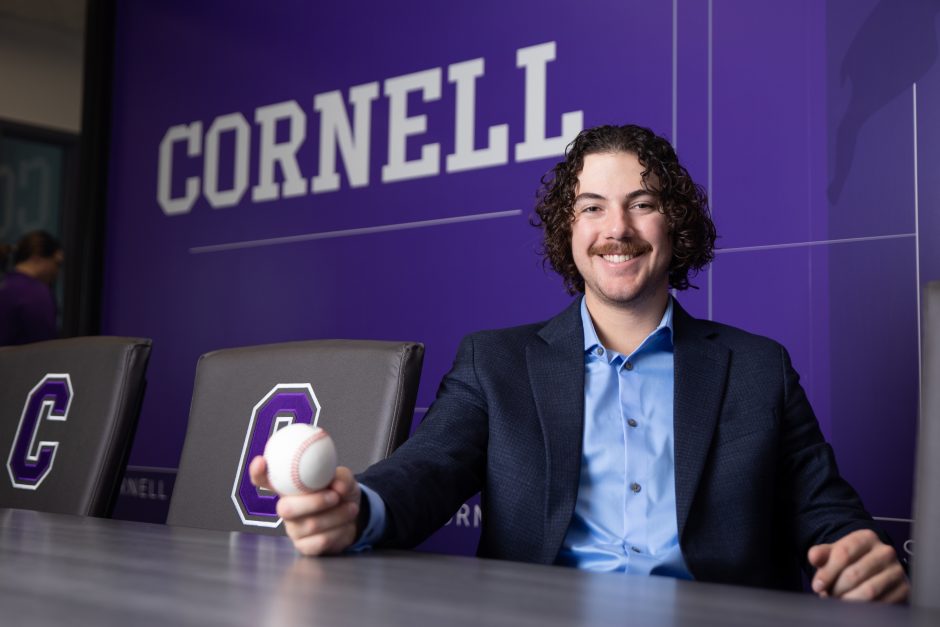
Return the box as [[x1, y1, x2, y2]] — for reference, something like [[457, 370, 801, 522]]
[[911, 281, 940, 609]]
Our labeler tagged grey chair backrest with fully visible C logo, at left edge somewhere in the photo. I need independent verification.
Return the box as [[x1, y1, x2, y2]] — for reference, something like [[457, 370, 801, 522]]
[[0, 337, 150, 516]]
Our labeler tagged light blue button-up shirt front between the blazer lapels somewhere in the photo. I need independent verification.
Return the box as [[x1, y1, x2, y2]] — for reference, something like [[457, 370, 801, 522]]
[[557, 299, 692, 579]]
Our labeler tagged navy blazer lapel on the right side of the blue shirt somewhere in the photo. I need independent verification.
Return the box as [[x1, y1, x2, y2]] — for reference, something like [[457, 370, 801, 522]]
[[673, 302, 729, 539]]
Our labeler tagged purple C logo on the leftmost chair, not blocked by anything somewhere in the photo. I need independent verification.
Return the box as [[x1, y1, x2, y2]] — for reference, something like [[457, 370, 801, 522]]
[[7, 374, 72, 490]]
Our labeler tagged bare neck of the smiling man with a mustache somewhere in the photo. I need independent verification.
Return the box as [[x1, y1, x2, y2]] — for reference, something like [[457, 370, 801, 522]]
[[584, 288, 669, 355]]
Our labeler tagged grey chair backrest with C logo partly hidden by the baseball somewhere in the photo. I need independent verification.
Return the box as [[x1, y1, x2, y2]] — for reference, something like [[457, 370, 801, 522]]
[[167, 340, 424, 534]]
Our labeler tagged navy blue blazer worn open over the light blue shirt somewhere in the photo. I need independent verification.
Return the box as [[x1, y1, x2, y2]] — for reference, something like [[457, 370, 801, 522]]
[[358, 300, 884, 589]]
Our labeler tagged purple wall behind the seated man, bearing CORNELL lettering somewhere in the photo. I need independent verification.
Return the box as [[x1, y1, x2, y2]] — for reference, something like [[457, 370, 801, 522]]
[[104, 0, 940, 551]]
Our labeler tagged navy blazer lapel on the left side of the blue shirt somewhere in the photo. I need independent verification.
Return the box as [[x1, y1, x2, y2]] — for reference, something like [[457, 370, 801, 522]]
[[526, 299, 584, 563]]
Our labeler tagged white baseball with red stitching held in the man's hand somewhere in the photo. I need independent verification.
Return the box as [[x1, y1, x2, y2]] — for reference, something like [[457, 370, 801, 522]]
[[264, 422, 336, 496]]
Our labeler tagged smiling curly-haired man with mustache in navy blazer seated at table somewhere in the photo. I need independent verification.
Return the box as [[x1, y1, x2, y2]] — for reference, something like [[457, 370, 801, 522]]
[[251, 126, 908, 601]]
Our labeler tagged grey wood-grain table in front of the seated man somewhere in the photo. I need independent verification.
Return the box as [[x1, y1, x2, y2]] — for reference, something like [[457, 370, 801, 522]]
[[0, 509, 940, 627]]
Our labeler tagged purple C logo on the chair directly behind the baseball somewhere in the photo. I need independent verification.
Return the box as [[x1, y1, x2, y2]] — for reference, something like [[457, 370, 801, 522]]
[[232, 383, 320, 527]]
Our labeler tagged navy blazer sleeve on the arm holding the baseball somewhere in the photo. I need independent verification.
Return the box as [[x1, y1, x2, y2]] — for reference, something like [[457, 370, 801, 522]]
[[357, 336, 488, 547]]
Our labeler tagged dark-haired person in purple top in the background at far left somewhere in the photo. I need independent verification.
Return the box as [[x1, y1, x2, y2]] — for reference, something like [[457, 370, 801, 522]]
[[0, 231, 64, 346]]
